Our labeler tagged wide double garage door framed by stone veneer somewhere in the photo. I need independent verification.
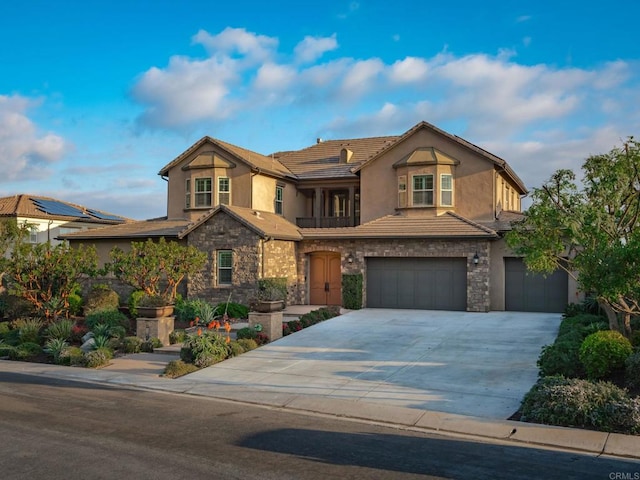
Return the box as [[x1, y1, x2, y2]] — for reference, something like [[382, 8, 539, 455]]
[[367, 258, 467, 311]]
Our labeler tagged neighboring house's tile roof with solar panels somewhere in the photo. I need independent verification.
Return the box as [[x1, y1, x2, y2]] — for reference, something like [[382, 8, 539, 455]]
[[0, 194, 133, 225]]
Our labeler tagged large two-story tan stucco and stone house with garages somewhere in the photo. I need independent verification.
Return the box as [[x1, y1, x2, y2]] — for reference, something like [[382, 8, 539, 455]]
[[67, 122, 575, 311]]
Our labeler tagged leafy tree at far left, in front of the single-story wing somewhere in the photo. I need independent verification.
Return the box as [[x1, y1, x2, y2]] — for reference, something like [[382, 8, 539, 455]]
[[7, 243, 98, 320]]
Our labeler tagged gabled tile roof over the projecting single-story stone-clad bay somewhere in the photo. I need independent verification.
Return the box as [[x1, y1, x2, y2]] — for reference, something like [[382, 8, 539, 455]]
[[179, 205, 302, 240]]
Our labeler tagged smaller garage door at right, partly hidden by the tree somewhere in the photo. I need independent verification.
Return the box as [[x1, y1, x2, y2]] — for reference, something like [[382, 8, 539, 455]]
[[504, 258, 568, 312]]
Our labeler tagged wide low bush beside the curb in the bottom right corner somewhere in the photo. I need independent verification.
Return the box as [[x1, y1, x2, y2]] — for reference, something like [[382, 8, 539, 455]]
[[521, 376, 640, 434]]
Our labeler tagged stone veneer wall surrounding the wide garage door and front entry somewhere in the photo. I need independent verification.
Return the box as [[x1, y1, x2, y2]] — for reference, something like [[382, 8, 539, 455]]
[[297, 239, 490, 312]]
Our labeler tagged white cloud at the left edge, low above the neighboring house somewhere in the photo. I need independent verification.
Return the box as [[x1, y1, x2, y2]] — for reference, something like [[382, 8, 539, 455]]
[[0, 95, 70, 182]]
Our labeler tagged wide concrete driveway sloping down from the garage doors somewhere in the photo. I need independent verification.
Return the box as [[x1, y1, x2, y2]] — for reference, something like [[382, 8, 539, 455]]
[[188, 309, 561, 419]]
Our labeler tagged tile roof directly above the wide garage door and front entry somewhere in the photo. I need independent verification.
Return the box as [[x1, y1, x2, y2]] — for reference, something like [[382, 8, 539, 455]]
[[300, 212, 498, 239]]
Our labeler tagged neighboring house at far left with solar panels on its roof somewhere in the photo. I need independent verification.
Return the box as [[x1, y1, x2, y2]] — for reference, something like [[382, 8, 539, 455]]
[[0, 194, 131, 245]]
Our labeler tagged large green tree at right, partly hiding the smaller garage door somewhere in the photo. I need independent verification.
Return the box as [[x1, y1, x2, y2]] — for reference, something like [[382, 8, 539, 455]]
[[507, 137, 640, 336]]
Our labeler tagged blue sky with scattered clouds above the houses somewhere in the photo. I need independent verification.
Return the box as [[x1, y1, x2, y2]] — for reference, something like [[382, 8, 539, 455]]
[[0, 0, 640, 219]]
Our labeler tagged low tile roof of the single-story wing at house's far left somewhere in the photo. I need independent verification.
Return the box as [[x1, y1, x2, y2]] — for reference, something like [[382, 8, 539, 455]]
[[60, 218, 191, 240]]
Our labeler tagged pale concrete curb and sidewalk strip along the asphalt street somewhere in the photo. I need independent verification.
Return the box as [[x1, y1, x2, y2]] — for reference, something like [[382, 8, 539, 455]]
[[0, 360, 640, 459]]
